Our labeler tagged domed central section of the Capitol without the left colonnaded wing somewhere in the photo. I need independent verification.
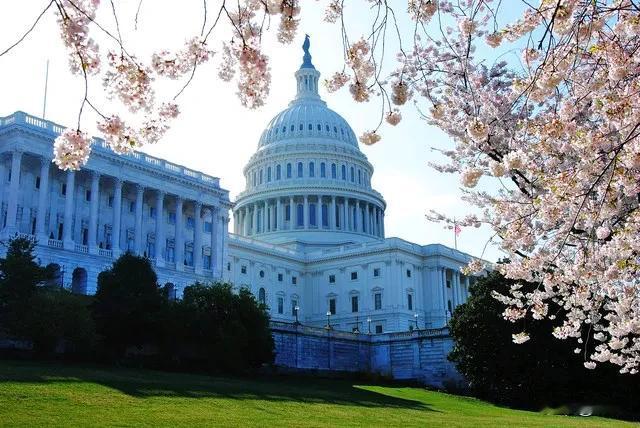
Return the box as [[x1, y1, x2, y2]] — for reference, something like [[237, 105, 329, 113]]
[[223, 42, 472, 333]]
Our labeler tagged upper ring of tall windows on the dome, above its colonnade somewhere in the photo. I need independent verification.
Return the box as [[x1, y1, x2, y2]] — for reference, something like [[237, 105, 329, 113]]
[[251, 161, 370, 187]]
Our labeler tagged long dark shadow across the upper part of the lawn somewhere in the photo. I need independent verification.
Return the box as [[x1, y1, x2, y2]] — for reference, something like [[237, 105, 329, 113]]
[[0, 360, 437, 412]]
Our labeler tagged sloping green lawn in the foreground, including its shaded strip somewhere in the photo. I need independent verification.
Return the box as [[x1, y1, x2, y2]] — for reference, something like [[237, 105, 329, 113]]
[[0, 360, 631, 428]]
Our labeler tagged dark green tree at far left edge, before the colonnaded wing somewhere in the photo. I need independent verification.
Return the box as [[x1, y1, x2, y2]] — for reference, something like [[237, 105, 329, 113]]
[[0, 237, 48, 335]]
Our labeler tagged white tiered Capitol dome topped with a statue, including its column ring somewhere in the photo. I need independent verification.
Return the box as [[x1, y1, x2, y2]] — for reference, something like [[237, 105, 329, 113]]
[[234, 37, 386, 246]]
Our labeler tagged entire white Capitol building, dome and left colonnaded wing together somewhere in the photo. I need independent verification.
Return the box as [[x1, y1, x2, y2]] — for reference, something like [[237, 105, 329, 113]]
[[0, 44, 472, 334]]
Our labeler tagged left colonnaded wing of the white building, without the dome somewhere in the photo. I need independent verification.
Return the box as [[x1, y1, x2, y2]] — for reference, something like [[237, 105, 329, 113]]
[[0, 112, 231, 295]]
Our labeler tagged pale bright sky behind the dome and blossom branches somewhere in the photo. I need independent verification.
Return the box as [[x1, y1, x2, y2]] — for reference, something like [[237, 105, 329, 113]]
[[0, 0, 528, 260]]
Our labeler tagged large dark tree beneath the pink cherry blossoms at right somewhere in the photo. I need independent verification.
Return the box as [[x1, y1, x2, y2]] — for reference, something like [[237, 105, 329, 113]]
[[449, 272, 640, 410]]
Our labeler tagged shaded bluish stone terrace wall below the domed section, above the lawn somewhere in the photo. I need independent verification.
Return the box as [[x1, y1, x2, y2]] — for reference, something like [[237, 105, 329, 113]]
[[271, 322, 462, 388]]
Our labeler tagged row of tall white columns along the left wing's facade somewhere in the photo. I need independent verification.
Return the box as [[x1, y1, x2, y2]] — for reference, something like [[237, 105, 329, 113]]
[[0, 150, 228, 273]]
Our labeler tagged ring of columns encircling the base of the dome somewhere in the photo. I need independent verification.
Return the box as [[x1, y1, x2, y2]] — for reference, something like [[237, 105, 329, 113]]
[[234, 194, 384, 238]]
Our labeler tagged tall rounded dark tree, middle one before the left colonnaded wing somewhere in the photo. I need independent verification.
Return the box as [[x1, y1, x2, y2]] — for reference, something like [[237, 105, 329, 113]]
[[93, 252, 165, 356]]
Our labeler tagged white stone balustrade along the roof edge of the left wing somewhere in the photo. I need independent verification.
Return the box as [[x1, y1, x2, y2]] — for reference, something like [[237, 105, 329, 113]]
[[0, 111, 220, 188]]
